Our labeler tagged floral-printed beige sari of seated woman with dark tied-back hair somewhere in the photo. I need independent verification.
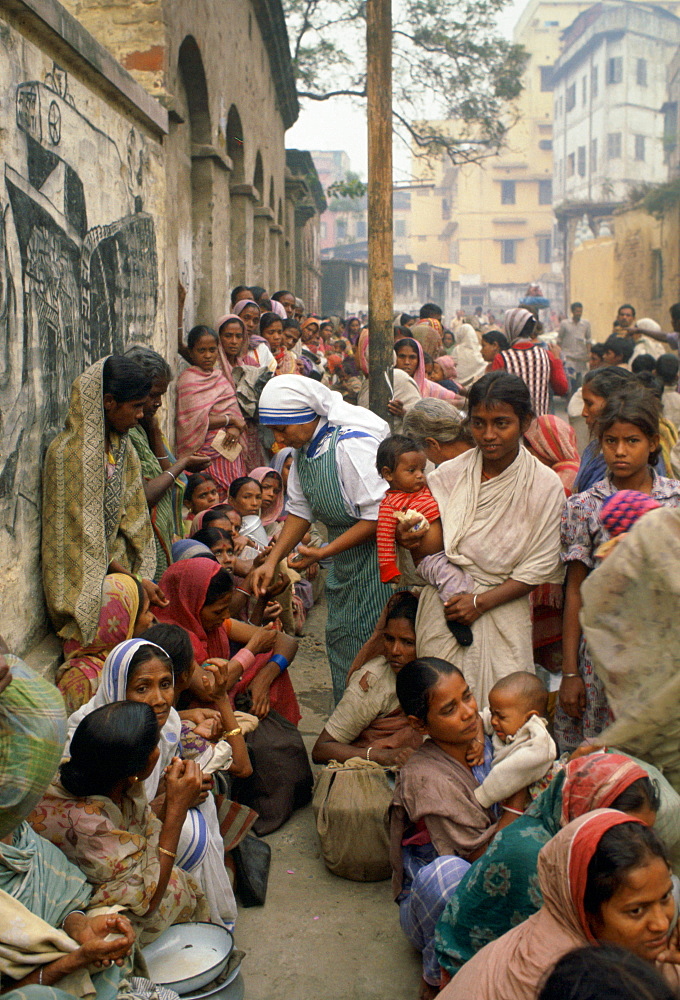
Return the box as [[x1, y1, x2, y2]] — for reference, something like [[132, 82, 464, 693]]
[[30, 782, 210, 944]]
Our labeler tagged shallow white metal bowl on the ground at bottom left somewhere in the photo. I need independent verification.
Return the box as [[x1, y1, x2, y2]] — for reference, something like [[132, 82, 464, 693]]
[[142, 922, 234, 996]]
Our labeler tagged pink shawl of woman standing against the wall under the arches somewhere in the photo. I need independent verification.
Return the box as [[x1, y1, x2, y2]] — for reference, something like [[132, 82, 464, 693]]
[[176, 365, 246, 500]]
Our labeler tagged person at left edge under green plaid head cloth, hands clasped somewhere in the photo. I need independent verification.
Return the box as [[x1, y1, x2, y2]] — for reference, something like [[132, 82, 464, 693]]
[[0, 654, 170, 1000]]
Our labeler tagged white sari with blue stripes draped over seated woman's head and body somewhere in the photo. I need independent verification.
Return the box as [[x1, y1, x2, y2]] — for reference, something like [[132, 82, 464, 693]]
[[64, 639, 236, 930]]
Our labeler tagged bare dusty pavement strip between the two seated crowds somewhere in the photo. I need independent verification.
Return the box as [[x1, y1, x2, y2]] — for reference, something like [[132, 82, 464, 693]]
[[236, 601, 420, 1000]]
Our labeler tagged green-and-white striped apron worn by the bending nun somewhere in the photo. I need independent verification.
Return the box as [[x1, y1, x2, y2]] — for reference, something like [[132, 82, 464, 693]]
[[297, 427, 392, 705]]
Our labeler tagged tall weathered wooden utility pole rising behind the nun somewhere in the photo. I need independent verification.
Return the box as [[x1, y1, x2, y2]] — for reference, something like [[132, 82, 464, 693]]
[[366, 0, 394, 420]]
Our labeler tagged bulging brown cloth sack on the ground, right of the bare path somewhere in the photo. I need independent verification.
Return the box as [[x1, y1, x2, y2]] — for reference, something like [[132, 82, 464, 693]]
[[312, 757, 392, 882]]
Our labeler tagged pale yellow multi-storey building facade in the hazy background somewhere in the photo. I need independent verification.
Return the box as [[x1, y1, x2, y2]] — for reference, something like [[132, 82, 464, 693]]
[[409, 0, 591, 309]]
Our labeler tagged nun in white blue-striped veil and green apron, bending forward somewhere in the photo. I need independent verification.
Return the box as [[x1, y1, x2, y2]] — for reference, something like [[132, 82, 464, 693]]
[[253, 375, 391, 703]]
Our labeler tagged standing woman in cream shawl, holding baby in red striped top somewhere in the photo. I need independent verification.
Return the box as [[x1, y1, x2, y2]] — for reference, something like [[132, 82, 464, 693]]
[[398, 372, 564, 706]]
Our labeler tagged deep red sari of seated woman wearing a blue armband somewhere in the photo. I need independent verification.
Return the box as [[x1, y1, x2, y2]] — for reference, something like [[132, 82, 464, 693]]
[[156, 557, 300, 726]]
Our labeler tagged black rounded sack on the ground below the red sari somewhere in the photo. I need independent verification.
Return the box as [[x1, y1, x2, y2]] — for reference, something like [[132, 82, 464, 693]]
[[233, 708, 313, 837]]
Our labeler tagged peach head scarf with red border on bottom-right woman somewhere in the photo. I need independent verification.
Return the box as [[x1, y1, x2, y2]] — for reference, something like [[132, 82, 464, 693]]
[[441, 809, 637, 1000]]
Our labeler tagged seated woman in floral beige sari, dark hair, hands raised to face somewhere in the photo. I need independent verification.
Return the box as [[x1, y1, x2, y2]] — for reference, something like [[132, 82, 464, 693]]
[[29, 701, 209, 944]]
